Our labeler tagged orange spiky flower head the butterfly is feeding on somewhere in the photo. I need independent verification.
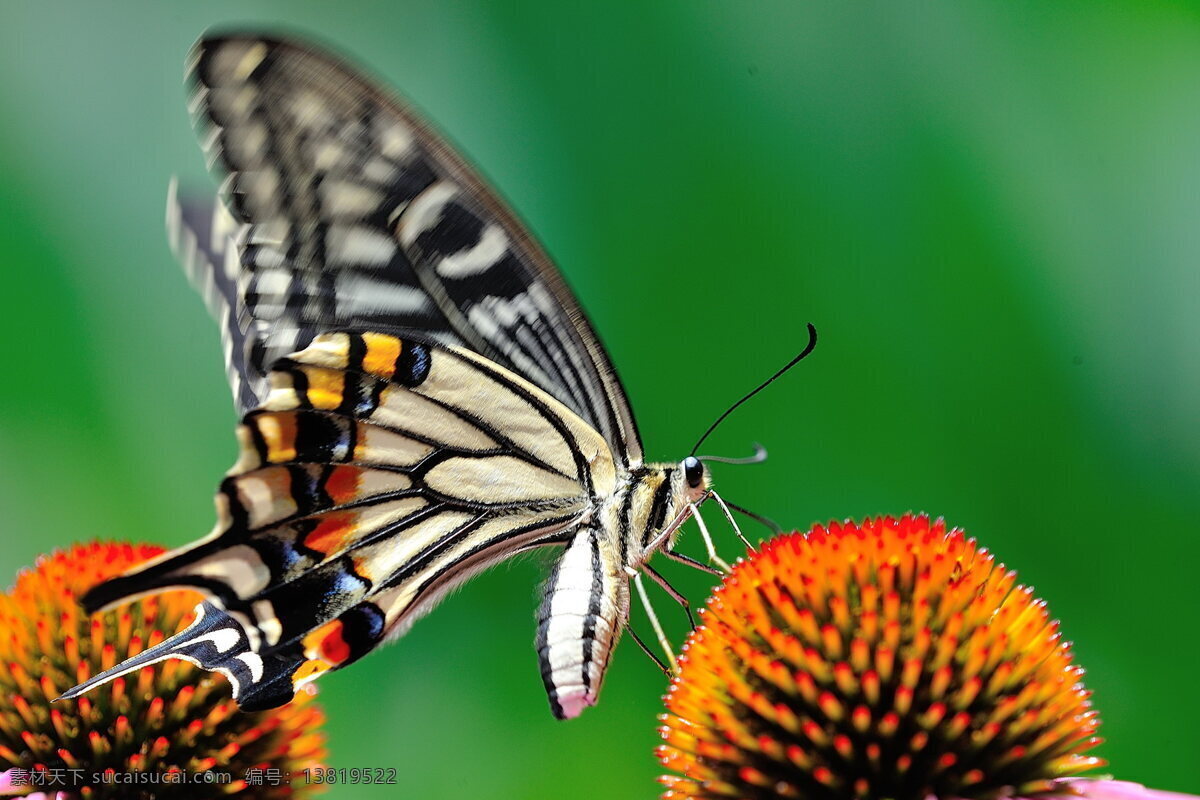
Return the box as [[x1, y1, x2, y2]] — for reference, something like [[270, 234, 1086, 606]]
[[658, 516, 1104, 800]]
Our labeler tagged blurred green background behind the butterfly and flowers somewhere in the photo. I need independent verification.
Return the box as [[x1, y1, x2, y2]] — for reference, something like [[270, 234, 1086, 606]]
[[0, 0, 1200, 800]]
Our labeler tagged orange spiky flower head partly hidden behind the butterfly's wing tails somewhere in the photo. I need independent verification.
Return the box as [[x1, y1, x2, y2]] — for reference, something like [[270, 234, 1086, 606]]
[[0, 543, 324, 800]]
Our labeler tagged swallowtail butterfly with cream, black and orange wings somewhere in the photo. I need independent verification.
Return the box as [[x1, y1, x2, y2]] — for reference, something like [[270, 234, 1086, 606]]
[[64, 35, 812, 718]]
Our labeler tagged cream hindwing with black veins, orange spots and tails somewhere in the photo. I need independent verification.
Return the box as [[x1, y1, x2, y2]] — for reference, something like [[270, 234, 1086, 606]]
[[65, 332, 616, 709]]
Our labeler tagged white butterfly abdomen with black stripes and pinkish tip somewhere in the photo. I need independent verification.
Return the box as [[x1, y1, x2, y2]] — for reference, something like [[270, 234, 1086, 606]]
[[538, 528, 629, 720]]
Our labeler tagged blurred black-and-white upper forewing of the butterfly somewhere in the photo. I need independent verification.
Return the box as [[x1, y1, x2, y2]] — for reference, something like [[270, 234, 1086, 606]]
[[188, 36, 642, 463]]
